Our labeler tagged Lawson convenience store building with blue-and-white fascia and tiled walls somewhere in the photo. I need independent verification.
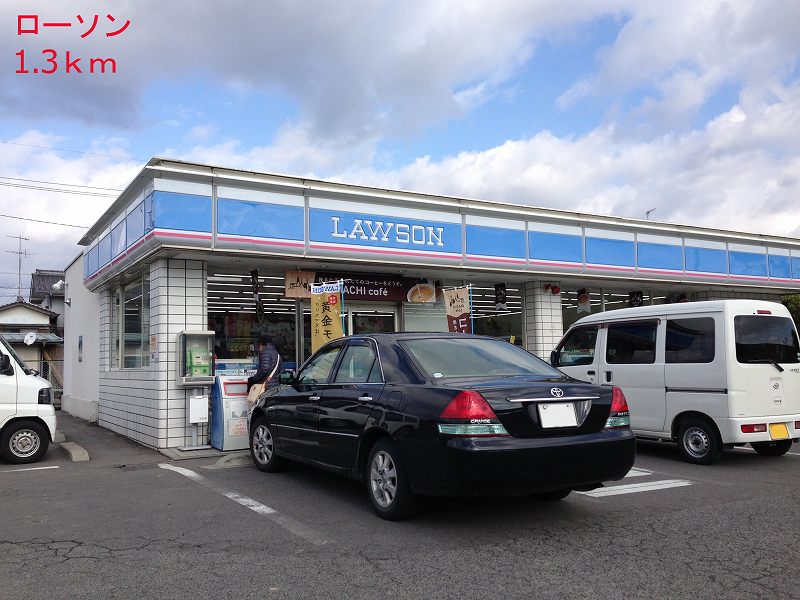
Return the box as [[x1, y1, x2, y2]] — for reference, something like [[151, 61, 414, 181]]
[[63, 158, 800, 448]]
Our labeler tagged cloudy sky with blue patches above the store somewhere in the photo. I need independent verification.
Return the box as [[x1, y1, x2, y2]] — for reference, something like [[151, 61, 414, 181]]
[[0, 0, 800, 303]]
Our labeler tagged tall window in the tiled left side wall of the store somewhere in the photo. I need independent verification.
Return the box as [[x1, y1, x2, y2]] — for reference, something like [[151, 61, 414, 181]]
[[111, 275, 150, 369]]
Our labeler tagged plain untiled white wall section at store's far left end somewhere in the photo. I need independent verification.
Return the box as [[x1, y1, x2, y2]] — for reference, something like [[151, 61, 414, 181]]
[[61, 256, 100, 422]]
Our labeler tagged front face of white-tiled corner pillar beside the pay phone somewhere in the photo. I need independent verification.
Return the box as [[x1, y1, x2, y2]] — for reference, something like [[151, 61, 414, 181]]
[[150, 259, 208, 448]]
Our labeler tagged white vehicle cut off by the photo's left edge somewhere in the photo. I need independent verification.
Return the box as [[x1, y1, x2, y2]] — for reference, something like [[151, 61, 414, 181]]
[[0, 336, 56, 464]]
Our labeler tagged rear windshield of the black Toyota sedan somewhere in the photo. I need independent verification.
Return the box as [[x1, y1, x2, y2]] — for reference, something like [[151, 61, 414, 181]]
[[400, 335, 564, 378]]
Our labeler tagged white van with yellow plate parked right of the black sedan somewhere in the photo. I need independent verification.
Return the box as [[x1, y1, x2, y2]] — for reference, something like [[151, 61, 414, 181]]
[[550, 300, 800, 464]]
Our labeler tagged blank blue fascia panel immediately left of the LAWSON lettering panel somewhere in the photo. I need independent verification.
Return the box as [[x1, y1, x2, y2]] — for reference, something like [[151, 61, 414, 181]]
[[217, 198, 305, 242]]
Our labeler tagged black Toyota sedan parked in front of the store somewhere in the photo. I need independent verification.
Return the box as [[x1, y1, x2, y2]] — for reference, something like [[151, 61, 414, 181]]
[[250, 333, 635, 519]]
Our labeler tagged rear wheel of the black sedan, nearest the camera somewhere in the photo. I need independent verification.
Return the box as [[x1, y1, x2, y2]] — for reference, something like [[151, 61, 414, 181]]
[[367, 439, 418, 521]]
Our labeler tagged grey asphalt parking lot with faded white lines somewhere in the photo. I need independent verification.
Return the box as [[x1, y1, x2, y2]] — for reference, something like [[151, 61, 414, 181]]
[[0, 418, 800, 598]]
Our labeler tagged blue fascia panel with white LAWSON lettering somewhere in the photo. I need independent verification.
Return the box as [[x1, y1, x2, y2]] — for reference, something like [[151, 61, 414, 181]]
[[309, 208, 461, 254]]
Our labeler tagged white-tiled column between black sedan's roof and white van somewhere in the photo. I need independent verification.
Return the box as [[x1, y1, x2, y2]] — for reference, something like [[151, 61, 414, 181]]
[[523, 281, 564, 360]]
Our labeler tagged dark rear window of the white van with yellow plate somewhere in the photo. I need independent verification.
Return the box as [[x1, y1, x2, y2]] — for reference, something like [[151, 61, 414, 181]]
[[733, 315, 800, 363]]
